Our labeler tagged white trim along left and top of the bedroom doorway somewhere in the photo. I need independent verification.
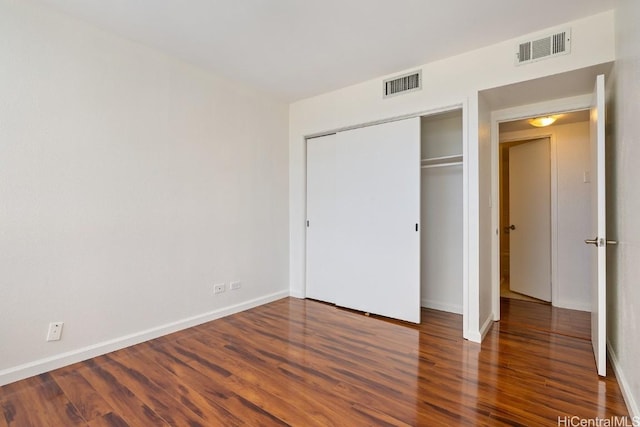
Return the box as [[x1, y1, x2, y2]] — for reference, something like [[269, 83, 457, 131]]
[[491, 94, 592, 320]]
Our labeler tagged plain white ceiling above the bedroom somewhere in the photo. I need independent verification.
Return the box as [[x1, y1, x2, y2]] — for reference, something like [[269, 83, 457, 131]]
[[27, 0, 615, 101]]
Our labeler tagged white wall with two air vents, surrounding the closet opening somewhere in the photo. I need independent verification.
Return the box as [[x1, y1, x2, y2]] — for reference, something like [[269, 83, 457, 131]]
[[289, 12, 614, 339]]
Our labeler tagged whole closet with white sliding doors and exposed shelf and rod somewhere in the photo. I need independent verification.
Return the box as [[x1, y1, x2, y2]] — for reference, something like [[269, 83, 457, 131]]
[[306, 112, 462, 323]]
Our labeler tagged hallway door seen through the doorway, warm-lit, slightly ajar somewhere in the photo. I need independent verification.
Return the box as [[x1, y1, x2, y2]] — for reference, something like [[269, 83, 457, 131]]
[[508, 138, 551, 301]]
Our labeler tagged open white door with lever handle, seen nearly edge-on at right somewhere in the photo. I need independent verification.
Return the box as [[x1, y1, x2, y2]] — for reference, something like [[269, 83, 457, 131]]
[[585, 75, 607, 376]]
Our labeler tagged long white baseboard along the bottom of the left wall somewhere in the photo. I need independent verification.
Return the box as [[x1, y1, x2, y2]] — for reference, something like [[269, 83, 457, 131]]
[[0, 290, 289, 386]]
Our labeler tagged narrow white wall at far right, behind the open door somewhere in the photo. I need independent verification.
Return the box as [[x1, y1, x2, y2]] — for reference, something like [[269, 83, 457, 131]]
[[607, 0, 640, 416]]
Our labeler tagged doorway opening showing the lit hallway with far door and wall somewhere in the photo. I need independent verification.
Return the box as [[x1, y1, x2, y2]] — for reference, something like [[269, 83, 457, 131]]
[[498, 110, 590, 311]]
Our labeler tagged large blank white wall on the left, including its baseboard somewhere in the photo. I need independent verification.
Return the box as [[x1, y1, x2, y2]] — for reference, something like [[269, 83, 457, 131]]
[[0, 0, 288, 384]]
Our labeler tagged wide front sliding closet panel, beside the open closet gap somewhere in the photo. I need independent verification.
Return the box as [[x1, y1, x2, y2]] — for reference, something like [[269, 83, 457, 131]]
[[335, 118, 420, 323]]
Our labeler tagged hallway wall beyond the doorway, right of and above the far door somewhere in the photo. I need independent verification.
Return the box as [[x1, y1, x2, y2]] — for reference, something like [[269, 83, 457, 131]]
[[500, 122, 591, 311]]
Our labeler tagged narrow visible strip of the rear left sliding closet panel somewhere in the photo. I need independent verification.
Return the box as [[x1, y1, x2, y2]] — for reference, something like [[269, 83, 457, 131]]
[[306, 134, 337, 302]]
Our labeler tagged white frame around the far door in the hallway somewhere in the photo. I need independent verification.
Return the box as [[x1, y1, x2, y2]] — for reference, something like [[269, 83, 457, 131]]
[[496, 135, 558, 304]]
